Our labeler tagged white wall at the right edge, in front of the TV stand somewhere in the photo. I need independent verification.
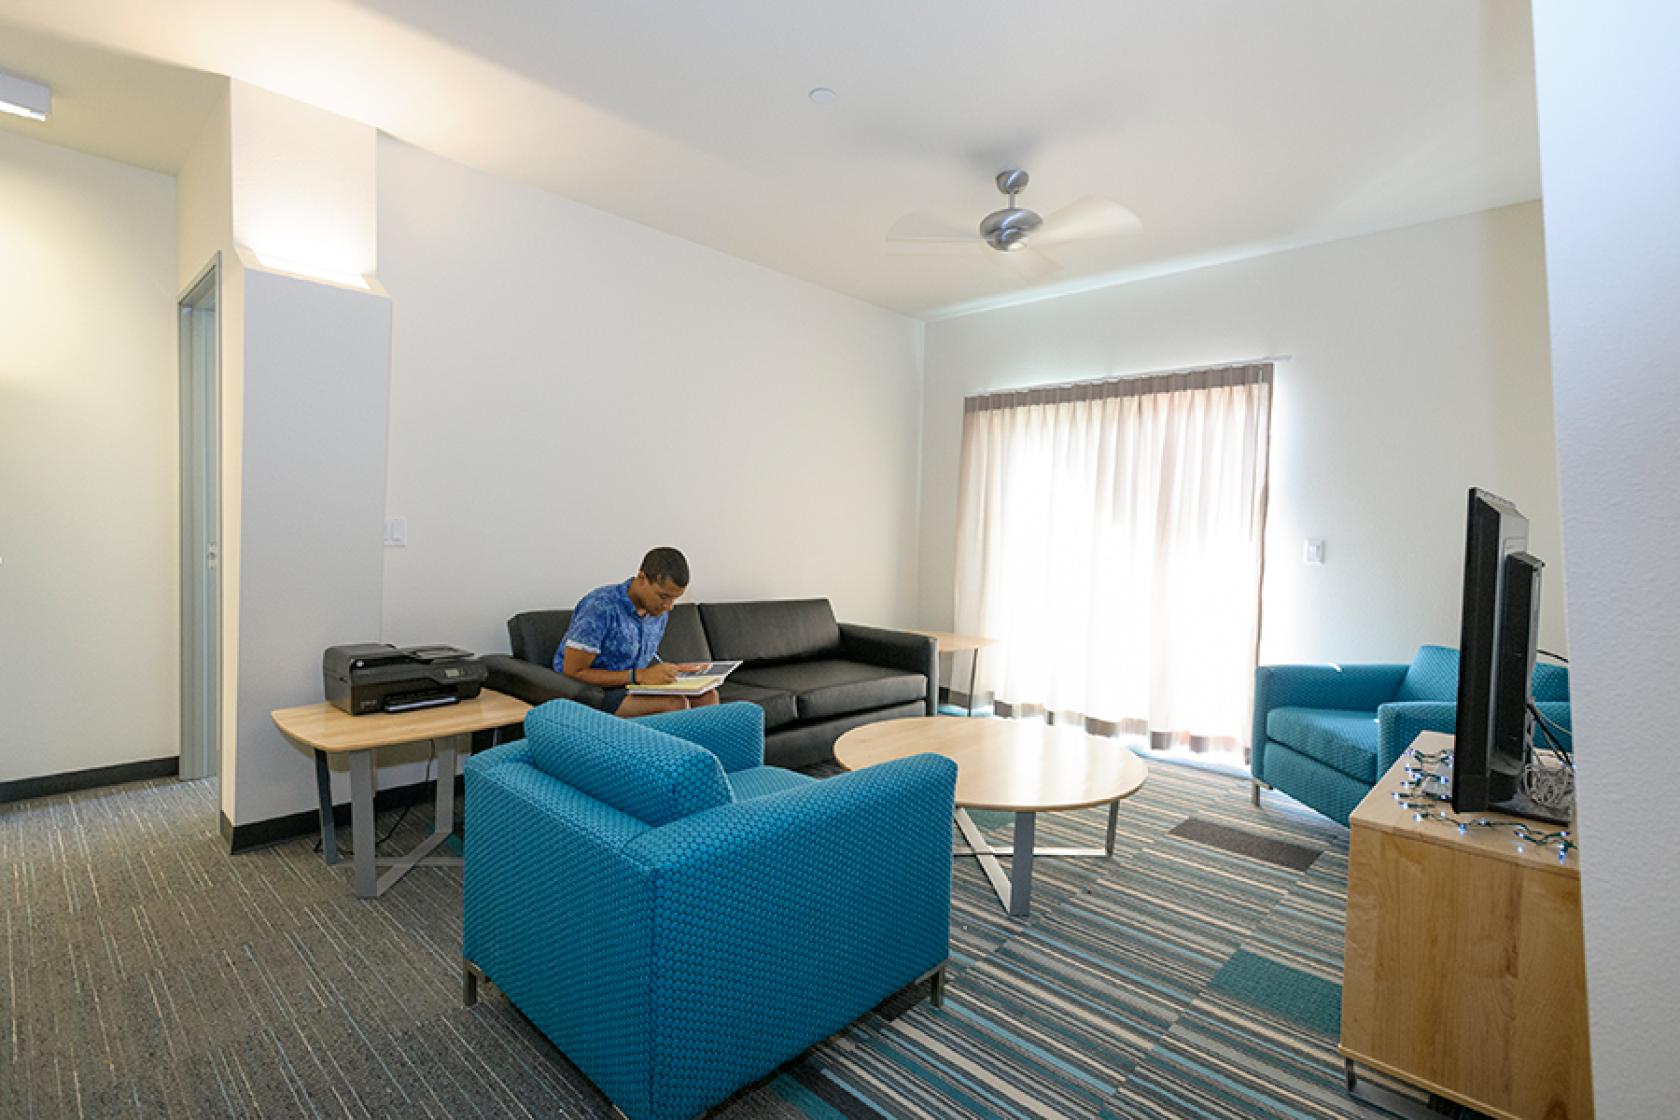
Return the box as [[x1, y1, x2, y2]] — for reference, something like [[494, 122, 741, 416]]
[[1534, 0, 1680, 1117]]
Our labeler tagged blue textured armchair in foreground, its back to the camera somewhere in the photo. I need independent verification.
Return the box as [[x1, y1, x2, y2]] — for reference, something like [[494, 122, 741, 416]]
[[462, 700, 956, 1120]]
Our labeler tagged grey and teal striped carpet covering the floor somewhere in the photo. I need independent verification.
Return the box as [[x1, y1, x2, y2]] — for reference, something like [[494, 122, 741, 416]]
[[0, 752, 1444, 1120]]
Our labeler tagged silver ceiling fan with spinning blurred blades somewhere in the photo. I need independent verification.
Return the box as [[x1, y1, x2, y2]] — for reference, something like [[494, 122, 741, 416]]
[[887, 168, 1142, 275]]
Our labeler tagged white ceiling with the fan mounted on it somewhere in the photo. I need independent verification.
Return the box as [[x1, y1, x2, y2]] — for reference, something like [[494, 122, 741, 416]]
[[0, 0, 1539, 314]]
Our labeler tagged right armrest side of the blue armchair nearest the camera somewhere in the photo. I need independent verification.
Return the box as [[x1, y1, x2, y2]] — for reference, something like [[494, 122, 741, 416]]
[[627, 756, 956, 1115]]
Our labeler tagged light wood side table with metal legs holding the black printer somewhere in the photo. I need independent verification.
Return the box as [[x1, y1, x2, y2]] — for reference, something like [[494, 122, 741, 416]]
[[270, 688, 531, 898]]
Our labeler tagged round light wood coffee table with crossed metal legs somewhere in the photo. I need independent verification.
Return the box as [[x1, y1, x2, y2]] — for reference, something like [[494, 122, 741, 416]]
[[835, 715, 1149, 917]]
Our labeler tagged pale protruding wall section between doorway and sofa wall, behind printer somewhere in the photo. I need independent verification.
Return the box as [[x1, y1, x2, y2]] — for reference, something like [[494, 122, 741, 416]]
[[223, 267, 389, 824]]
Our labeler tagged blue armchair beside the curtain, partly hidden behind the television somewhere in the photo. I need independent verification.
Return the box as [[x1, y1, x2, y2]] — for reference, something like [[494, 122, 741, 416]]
[[1252, 645, 1569, 824]]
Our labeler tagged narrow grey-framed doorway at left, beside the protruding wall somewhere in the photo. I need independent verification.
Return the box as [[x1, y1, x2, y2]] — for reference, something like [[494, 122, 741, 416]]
[[178, 254, 222, 781]]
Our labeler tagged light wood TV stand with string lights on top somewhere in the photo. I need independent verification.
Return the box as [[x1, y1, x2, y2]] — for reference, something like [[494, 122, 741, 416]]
[[1341, 732, 1593, 1120]]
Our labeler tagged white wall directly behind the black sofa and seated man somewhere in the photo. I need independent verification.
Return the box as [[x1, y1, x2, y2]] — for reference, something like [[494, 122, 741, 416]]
[[380, 138, 921, 652]]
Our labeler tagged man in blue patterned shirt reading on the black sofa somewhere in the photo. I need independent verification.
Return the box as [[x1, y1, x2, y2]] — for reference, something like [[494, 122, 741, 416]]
[[554, 547, 717, 717]]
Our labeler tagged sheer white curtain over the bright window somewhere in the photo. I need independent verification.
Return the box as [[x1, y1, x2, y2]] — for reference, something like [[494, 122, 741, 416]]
[[956, 364, 1272, 742]]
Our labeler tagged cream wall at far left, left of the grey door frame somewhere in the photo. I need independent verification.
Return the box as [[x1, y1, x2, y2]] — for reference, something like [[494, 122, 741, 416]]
[[0, 133, 180, 781]]
